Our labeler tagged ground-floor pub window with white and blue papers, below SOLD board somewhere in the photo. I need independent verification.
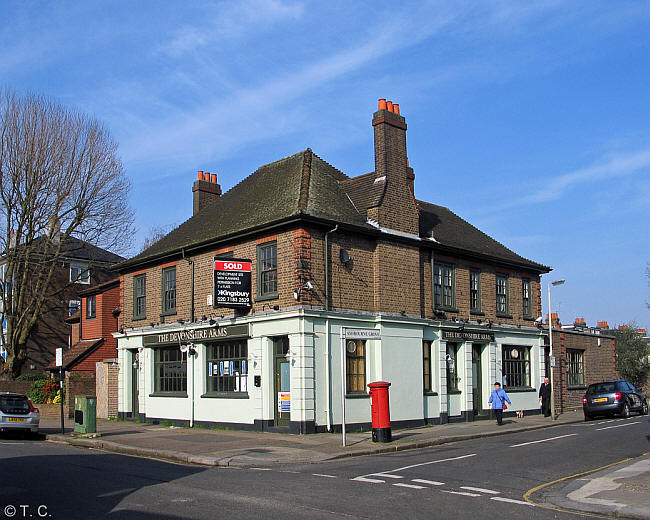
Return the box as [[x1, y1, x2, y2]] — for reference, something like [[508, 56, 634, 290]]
[[207, 340, 248, 394]]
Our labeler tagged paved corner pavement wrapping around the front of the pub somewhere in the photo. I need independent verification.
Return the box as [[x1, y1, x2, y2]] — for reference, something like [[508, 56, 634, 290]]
[[40, 411, 583, 467]]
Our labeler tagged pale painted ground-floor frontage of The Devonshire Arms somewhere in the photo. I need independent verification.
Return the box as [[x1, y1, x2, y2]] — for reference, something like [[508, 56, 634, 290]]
[[116, 307, 545, 433]]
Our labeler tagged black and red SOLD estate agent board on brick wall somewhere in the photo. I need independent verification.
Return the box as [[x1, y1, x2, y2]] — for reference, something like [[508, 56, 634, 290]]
[[214, 258, 252, 308]]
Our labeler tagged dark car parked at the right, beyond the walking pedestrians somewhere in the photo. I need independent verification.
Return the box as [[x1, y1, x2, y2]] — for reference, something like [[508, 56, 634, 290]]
[[582, 381, 648, 421]]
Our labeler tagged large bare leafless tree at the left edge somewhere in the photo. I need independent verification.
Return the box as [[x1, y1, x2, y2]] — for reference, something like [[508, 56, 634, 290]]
[[0, 89, 133, 376]]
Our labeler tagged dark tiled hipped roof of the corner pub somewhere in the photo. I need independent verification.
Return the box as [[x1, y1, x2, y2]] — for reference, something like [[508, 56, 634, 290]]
[[116, 148, 550, 272]]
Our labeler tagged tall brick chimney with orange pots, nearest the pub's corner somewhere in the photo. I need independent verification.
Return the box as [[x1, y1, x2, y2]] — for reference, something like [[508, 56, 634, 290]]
[[368, 99, 419, 235]]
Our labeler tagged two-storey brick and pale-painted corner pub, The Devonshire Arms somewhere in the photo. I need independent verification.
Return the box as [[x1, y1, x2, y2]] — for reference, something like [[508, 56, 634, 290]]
[[116, 99, 550, 433]]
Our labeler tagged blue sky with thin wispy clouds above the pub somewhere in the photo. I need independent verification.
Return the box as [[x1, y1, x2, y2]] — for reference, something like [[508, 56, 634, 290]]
[[0, 0, 650, 328]]
